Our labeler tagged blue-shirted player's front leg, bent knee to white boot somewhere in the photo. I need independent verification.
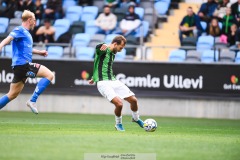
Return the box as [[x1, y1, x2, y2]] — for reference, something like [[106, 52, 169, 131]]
[[27, 65, 54, 114]]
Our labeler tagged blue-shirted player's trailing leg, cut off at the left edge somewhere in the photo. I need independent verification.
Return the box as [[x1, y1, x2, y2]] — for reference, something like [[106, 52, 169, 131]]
[[0, 81, 24, 109]]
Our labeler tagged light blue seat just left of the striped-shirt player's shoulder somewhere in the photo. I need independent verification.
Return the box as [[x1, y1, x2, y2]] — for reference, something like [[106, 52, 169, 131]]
[[76, 47, 95, 60]]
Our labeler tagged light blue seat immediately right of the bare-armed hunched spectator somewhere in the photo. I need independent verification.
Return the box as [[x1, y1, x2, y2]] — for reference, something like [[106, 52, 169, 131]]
[[53, 19, 70, 41]]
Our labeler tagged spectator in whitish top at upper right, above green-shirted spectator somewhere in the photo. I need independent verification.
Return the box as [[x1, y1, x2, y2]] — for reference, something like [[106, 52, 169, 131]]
[[213, 0, 231, 20]]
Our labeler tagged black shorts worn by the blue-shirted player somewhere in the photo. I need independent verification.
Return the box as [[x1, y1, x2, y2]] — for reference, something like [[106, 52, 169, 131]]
[[12, 63, 41, 83]]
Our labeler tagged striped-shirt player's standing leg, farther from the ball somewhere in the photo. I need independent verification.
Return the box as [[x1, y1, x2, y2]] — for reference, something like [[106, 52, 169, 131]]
[[111, 97, 125, 131]]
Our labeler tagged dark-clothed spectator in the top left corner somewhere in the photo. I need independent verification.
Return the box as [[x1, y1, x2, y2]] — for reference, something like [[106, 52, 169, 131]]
[[1, 0, 18, 18]]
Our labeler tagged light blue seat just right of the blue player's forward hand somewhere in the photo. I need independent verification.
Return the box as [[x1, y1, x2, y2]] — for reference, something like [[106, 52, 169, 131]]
[[46, 46, 63, 59]]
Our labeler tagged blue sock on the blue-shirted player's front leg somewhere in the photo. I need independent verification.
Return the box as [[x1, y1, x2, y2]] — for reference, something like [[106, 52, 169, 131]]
[[30, 78, 51, 102]]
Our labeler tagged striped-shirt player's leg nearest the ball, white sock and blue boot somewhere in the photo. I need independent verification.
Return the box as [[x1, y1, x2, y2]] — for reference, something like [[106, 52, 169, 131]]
[[125, 96, 144, 128]]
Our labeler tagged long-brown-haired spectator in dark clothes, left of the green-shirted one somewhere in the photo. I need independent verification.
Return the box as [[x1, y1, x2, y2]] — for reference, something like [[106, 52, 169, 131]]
[[207, 18, 221, 37]]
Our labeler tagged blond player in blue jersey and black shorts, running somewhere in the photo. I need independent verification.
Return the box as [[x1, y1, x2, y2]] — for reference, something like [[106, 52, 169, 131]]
[[0, 10, 54, 114]]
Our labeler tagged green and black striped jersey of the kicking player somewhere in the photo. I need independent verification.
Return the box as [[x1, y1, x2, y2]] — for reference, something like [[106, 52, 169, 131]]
[[93, 44, 116, 82]]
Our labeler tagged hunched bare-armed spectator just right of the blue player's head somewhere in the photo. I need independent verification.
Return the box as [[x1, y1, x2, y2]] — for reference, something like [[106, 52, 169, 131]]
[[36, 19, 55, 43]]
